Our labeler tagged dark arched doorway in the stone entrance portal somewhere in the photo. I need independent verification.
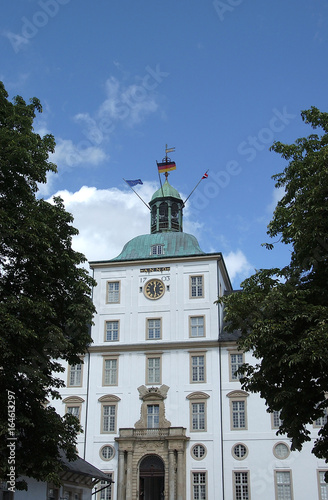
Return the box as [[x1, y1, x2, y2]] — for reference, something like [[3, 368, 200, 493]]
[[139, 455, 164, 500]]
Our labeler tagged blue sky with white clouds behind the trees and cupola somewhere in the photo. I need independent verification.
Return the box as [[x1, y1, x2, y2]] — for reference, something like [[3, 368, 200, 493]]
[[0, 0, 328, 288]]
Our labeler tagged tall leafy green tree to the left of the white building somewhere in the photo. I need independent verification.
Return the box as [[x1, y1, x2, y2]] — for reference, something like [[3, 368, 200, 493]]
[[0, 82, 94, 481]]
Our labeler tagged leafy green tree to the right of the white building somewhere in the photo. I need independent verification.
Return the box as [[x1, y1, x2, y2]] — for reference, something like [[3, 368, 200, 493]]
[[222, 107, 328, 460]]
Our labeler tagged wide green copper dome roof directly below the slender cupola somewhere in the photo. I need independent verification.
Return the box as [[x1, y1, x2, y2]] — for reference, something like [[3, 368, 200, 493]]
[[112, 232, 205, 261]]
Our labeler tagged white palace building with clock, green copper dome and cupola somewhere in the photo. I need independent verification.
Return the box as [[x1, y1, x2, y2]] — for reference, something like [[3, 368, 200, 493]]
[[53, 176, 328, 500]]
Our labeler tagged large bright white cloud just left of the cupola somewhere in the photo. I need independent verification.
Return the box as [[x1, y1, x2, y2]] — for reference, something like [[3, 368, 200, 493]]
[[47, 182, 157, 261]]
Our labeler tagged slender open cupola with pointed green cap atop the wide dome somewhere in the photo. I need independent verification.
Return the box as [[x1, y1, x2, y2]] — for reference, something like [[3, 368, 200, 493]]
[[149, 178, 184, 234]]
